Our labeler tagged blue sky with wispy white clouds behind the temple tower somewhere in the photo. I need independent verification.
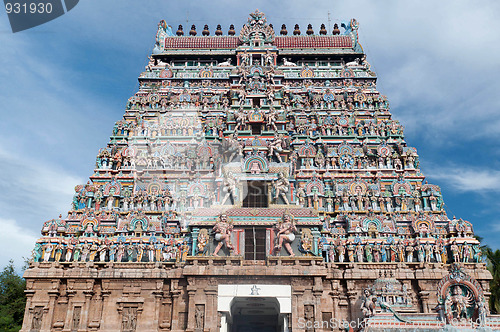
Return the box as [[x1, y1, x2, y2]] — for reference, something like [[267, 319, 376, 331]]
[[0, 0, 500, 266]]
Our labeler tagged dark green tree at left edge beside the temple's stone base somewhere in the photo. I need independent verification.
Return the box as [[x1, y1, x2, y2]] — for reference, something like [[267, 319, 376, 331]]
[[0, 260, 26, 332]]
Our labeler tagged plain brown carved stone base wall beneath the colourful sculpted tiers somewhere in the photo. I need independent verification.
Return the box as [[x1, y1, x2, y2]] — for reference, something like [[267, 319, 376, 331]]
[[21, 257, 491, 332]]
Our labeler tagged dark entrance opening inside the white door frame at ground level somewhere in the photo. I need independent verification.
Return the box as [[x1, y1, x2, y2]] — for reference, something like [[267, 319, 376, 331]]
[[231, 297, 281, 332]]
